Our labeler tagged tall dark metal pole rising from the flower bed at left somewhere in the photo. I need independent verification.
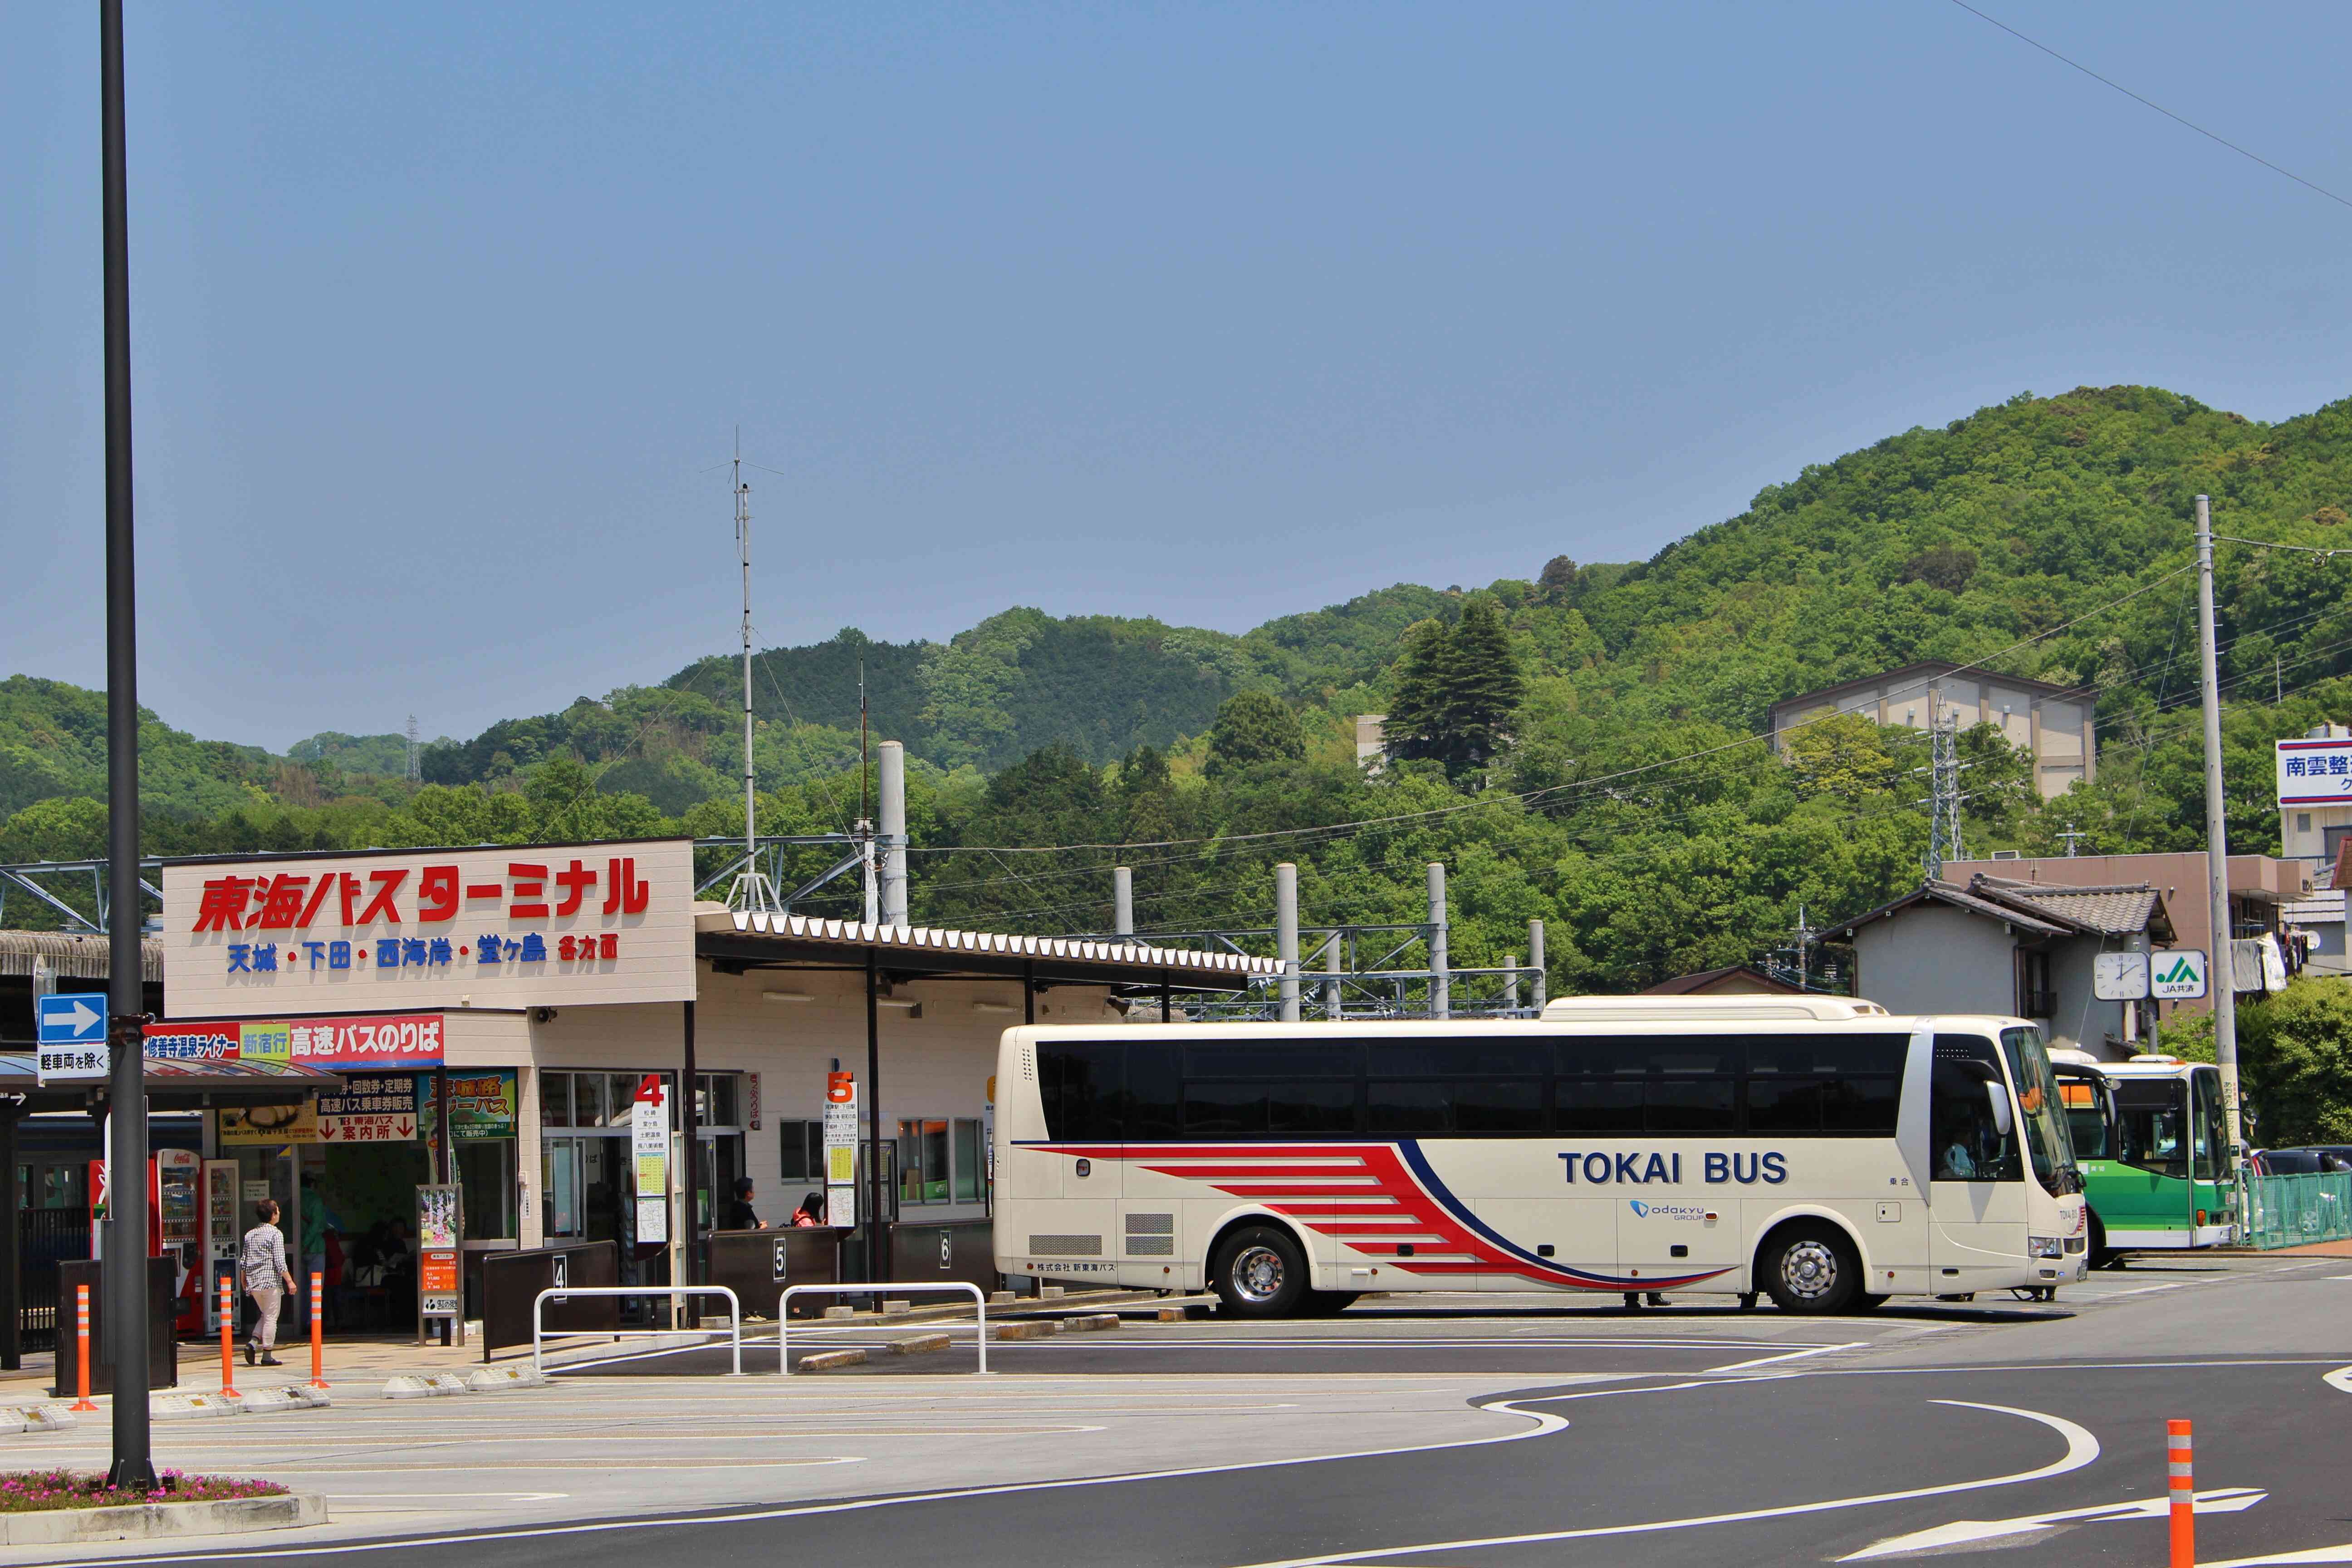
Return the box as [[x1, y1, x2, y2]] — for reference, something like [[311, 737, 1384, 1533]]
[[100, 0, 155, 1490]]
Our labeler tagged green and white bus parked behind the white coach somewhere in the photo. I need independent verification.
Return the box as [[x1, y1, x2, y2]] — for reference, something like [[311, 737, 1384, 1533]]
[[2051, 1051, 2237, 1269]]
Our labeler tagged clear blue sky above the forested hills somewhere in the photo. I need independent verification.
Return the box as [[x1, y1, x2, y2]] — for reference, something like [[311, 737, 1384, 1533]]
[[0, 0, 2352, 748]]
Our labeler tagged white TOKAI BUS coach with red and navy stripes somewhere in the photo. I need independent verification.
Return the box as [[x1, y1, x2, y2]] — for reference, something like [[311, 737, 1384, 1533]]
[[995, 997, 2086, 1317]]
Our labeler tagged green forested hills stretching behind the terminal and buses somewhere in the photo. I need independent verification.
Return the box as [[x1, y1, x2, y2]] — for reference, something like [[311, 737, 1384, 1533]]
[[0, 388, 2352, 987]]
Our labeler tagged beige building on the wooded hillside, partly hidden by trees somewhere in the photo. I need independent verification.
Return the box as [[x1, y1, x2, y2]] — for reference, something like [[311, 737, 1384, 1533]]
[[1771, 658, 2098, 799]]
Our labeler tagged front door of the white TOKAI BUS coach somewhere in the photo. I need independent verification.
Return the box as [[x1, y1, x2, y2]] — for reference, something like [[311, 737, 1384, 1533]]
[[1929, 1034, 2028, 1293]]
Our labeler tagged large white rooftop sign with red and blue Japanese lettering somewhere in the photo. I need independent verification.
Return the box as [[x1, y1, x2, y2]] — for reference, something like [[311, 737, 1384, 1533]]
[[162, 839, 694, 1018]]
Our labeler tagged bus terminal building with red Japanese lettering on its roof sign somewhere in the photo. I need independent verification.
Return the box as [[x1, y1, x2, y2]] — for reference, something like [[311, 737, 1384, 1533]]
[[133, 839, 1277, 1316]]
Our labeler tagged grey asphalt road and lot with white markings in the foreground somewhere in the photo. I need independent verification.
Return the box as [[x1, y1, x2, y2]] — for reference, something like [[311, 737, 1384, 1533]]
[[7, 1260, 2352, 1568]]
